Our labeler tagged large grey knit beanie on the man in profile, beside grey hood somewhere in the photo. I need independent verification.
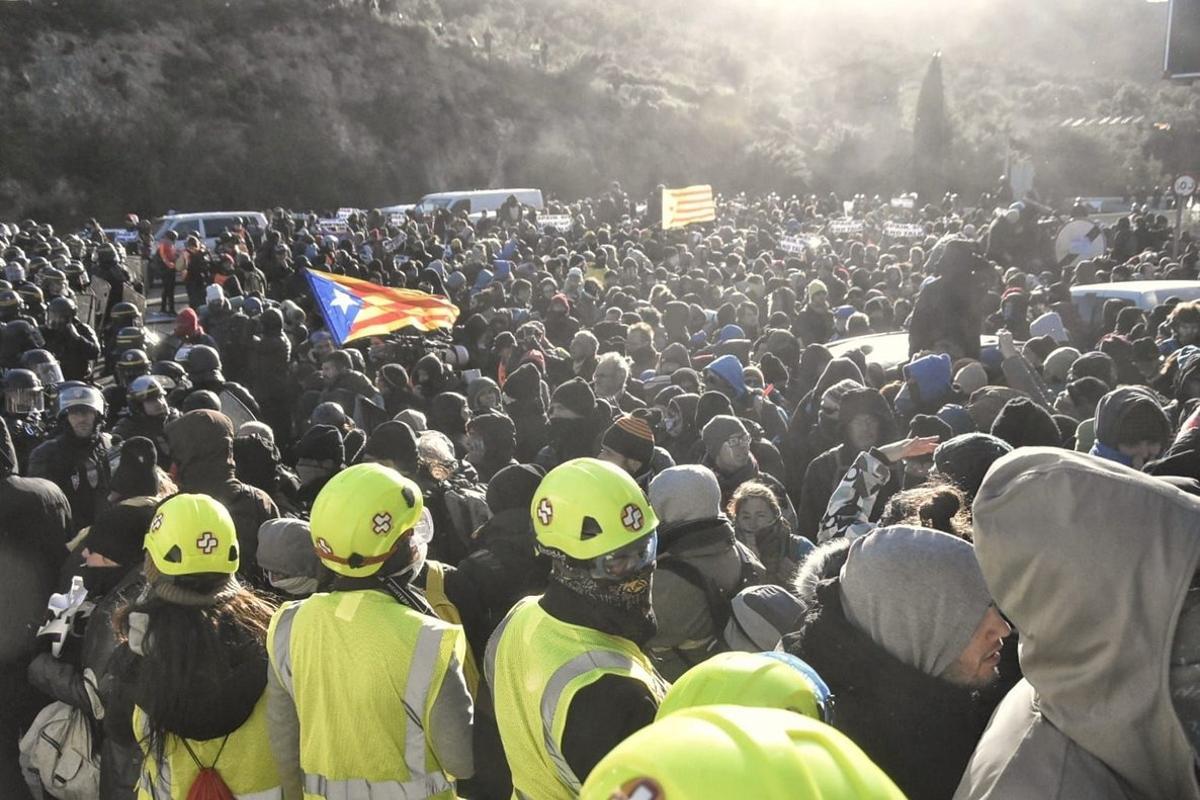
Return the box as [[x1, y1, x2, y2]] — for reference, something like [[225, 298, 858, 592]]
[[839, 525, 991, 675]]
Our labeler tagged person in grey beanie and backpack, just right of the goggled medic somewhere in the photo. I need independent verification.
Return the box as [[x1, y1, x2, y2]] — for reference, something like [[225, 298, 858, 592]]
[[646, 464, 764, 681]]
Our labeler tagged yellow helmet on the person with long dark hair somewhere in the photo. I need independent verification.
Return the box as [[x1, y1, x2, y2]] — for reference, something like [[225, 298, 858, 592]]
[[143, 494, 240, 576]]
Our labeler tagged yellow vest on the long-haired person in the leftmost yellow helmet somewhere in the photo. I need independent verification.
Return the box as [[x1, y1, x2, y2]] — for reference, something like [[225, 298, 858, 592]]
[[133, 692, 283, 800]]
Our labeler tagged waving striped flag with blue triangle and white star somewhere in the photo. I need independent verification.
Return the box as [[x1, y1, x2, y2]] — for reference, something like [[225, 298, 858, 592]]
[[305, 270, 458, 347]]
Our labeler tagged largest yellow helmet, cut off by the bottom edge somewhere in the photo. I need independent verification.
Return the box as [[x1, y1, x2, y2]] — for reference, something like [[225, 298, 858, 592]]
[[580, 705, 904, 800]]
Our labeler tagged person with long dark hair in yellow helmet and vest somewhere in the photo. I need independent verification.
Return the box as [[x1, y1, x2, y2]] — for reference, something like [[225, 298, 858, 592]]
[[114, 494, 282, 800]]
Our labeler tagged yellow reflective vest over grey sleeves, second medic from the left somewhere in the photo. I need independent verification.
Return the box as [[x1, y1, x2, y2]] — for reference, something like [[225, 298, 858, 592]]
[[266, 590, 467, 800]]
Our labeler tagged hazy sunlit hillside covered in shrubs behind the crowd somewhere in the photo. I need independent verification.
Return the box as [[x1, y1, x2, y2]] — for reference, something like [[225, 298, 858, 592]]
[[0, 0, 1200, 224]]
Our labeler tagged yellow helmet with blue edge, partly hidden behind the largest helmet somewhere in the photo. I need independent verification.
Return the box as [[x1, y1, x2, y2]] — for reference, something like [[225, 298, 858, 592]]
[[655, 652, 833, 723]]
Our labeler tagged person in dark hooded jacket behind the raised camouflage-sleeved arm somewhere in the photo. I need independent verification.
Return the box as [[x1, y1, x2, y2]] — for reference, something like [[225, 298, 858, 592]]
[[796, 389, 901, 541]]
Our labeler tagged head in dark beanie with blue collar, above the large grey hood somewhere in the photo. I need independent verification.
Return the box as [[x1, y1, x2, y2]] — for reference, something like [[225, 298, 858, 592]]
[[1090, 386, 1174, 469]]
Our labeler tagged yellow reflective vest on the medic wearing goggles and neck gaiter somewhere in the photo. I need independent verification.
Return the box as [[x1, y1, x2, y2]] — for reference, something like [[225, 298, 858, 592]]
[[484, 597, 667, 800]]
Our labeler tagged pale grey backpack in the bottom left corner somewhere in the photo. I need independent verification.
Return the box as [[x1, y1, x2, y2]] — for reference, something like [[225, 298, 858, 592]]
[[20, 700, 100, 800]]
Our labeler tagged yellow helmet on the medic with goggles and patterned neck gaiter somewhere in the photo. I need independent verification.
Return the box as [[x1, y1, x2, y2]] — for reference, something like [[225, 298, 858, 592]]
[[529, 458, 659, 561]]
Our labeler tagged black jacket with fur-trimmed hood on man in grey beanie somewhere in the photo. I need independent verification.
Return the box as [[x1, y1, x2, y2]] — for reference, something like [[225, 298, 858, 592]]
[[784, 541, 988, 800]]
